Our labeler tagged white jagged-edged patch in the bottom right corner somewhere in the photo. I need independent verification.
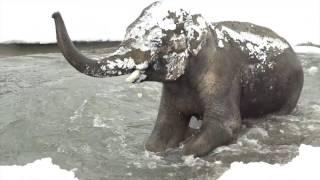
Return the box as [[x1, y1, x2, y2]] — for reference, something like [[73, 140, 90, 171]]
[[218, 145, 320, 180]]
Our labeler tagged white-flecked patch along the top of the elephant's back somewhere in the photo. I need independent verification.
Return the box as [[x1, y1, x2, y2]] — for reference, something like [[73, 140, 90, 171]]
[[211, 21, 290, 63]]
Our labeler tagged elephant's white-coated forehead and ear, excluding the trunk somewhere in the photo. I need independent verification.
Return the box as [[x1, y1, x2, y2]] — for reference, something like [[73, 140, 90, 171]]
[[122, 2, 209, 80]]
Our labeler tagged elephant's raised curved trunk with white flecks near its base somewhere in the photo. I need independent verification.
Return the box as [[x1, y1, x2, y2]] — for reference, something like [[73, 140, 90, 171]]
[[52, 12, 135, 77]]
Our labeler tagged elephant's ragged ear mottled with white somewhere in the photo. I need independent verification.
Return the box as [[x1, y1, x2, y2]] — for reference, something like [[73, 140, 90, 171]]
[[154, 10, 208, 81]]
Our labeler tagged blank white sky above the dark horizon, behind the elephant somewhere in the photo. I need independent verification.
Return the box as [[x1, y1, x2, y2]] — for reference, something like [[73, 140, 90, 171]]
[[0, 0, 320, 44]]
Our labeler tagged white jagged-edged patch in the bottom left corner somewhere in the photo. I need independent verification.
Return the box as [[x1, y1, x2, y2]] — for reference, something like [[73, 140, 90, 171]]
[[0, 158, 78, 180]]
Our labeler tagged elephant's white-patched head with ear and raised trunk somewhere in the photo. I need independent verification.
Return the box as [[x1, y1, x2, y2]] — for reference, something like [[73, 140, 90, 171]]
[[52, 2, 209, 82]]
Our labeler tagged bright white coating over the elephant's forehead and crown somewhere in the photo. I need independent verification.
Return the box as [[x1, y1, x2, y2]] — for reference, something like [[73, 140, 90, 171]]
[[124, 1, 208, 56]]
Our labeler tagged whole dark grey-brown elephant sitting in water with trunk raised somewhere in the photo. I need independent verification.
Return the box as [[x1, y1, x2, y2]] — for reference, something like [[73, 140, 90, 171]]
[[52, 2, 304, 156]]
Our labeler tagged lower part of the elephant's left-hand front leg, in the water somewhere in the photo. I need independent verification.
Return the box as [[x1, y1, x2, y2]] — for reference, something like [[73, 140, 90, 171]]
[[145, 104, 189, 152]]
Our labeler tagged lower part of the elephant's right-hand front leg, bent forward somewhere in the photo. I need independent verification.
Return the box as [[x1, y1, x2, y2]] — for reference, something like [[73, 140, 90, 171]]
[[183, 102, 241, 156]]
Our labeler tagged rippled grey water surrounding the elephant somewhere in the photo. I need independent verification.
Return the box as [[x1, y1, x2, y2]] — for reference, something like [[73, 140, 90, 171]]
[[0, 45, 320, 180]]
